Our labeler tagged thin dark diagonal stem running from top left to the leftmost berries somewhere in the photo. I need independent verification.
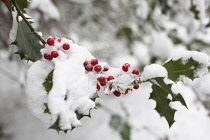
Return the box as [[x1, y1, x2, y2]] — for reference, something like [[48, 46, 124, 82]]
[[12, 0, 46, 45]]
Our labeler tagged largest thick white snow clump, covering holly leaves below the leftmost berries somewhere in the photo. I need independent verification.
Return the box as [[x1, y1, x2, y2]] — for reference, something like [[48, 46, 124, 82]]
[[26, 38, 96, 130]]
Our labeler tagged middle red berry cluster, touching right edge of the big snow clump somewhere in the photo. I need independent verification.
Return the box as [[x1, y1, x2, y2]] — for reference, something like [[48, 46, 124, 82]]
[[83, 59, 109, 73]]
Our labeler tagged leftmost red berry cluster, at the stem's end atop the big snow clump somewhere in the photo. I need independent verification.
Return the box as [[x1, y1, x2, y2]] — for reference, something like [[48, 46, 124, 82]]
[[44, 38, 70, 60]]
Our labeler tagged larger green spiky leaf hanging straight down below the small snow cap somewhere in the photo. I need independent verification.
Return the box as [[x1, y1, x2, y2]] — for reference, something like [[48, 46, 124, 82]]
[[149, 81, 176, 127]]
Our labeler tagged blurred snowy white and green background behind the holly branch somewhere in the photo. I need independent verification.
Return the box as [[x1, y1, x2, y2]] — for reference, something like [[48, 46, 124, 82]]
[[0, 0, 210, 140]]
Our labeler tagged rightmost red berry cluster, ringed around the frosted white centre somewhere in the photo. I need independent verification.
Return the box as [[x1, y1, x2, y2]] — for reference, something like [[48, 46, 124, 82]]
[[97, 63, 140, 97]]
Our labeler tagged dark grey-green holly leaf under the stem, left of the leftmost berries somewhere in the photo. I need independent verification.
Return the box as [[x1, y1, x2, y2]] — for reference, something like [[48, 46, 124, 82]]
[[13, 21, 43, 61]]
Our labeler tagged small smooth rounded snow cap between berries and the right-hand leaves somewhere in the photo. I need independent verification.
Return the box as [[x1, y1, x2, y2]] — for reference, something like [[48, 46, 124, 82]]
[[141, 64, 168, 81]]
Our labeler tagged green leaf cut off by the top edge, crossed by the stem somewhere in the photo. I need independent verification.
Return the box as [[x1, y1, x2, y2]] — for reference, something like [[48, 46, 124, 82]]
[[5, 0, 29, 12]]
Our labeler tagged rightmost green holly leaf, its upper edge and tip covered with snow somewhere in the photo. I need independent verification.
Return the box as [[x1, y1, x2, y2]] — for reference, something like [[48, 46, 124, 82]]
[[163, 58, 201, 82]]
